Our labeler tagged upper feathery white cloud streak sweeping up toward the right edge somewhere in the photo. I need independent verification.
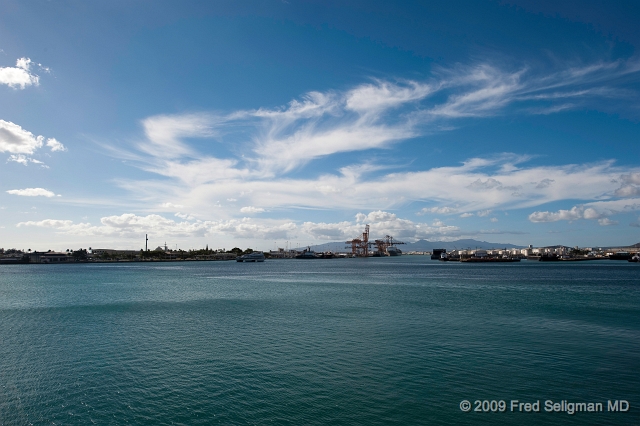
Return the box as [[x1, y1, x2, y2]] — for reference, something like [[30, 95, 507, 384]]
[[121, 61, 640, 183]]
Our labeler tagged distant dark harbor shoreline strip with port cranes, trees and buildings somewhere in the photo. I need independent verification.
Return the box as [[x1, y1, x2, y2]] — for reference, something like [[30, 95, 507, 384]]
[[0, 225, 640, 264]]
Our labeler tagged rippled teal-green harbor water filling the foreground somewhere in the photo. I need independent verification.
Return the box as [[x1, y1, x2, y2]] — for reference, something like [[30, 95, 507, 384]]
[[0, 256, 640, 425]]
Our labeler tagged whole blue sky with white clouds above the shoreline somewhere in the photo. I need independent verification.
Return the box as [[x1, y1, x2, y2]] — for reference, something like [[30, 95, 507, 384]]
[[0, 0, 640, 251]]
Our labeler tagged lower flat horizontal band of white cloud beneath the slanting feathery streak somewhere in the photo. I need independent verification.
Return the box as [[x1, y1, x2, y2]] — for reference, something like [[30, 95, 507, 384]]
[[115, 156, 635, 225]]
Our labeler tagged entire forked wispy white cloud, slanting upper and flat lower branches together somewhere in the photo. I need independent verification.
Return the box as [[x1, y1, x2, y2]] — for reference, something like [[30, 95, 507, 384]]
[[91, 57, 640, 232]]
